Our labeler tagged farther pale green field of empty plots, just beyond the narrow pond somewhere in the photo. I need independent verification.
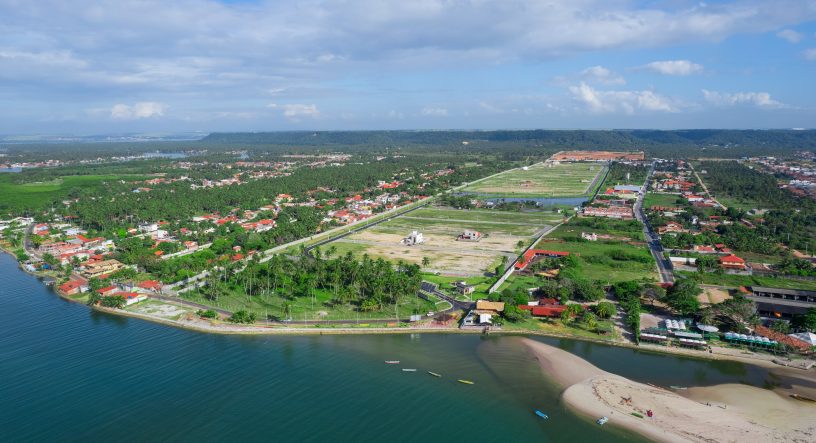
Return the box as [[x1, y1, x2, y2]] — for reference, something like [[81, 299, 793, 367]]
[[463, 163, 606, 198]]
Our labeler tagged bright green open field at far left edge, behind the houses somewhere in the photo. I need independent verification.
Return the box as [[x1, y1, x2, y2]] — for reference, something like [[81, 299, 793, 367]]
[[0, 174, 144, 212]]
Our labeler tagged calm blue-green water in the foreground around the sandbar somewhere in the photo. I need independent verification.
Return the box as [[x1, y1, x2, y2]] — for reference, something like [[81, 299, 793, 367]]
[[0, 254, 800, 443]]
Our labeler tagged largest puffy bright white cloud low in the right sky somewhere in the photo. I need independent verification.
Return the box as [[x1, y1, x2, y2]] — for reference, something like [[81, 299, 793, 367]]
[[569, 82, 678, 114]]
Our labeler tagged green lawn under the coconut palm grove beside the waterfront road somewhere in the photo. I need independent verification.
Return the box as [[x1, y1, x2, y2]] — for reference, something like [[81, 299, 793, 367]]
[[182, 290, 437, 322]]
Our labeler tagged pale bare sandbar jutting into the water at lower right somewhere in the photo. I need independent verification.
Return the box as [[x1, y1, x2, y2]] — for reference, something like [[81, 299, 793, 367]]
[[522, 339, 816, 443]]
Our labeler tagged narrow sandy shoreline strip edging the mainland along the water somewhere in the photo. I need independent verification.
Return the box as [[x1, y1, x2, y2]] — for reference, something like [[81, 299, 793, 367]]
[[0, 248, 802, 371]]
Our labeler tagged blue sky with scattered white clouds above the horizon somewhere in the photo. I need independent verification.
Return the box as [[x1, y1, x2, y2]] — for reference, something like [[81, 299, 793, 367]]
[[0, 0, 816, 135]]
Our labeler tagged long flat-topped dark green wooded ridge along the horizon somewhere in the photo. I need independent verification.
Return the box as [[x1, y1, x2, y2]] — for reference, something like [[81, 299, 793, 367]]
[[201, 129, 816, 157]]
